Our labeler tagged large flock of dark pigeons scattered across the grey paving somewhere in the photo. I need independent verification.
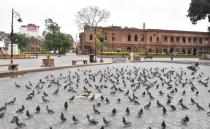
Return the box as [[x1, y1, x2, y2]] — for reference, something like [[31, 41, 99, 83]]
[[0, 63, 210, 129]]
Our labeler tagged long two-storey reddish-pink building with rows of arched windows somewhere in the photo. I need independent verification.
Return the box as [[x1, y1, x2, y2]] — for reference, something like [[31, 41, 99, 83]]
[[79, 26, 210, 55]]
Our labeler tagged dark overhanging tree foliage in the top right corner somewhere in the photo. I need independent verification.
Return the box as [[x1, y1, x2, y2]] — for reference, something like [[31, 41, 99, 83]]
[[187, 0, 210, 32]]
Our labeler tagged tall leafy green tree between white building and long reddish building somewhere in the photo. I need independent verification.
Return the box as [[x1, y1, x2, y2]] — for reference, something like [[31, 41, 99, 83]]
[[43, 19, 73, 54]]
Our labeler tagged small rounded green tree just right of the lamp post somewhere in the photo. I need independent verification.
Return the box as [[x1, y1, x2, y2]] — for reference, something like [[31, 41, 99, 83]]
[[16, 34, 31, 51]]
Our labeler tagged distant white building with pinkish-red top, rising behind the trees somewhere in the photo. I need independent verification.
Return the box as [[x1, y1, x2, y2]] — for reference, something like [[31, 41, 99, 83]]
[[19, 24, 39, 38]]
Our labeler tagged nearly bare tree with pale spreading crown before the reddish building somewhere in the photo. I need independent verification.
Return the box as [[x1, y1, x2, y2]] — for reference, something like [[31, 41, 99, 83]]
[[76, 6, 110, 58]]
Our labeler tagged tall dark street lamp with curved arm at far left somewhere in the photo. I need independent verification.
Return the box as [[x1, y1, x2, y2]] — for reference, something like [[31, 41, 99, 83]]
[[10, 8, 22, 64]]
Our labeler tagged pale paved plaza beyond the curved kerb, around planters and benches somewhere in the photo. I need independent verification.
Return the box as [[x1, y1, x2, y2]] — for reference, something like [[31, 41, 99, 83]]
[[0, 53, 210, 72]]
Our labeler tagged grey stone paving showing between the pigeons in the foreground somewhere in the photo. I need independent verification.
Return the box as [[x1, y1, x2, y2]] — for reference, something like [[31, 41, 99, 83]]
[[0, 63, 210, 129]]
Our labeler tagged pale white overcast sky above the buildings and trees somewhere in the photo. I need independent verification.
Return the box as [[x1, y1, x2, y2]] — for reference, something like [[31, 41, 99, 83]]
[[0, 0, 208, 39]]
